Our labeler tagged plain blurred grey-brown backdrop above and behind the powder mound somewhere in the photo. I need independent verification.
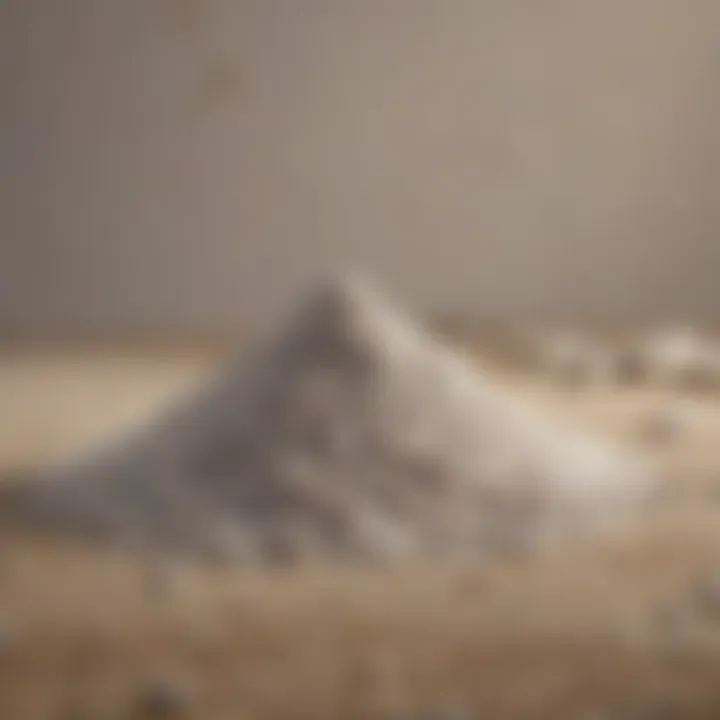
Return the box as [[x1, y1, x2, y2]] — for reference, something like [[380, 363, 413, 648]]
[[0, 0, 720, 336]]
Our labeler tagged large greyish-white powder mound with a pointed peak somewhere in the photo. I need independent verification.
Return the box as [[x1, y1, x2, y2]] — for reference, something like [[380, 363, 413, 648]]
[[11, 279, 652, 560]]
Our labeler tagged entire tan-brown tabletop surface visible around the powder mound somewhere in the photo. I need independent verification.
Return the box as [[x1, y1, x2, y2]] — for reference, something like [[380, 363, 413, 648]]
[[0, 349, 720, 720]]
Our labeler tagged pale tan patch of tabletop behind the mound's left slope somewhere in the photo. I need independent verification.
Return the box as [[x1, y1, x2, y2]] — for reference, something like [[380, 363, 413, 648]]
[[0, 348, 216, 472]]
